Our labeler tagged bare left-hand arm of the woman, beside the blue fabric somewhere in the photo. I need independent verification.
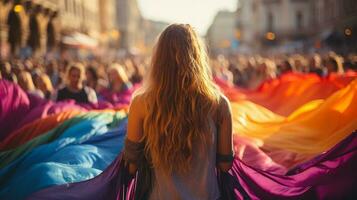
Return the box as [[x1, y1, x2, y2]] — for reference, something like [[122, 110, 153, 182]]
[[124, 96, 145, 174]]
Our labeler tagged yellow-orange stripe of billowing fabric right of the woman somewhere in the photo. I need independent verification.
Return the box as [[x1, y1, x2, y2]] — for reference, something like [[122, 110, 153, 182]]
[[232, 80, 357, 154]]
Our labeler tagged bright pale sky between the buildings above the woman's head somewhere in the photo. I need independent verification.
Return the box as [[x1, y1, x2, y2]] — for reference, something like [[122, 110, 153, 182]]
[[138, 0, 238, 35]]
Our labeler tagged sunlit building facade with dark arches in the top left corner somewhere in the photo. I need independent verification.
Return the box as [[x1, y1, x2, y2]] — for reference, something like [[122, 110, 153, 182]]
[[0, 0, 58, 58]]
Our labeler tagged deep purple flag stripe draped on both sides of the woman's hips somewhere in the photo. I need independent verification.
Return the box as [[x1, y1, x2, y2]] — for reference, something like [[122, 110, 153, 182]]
[[29, 133, 357, 199]]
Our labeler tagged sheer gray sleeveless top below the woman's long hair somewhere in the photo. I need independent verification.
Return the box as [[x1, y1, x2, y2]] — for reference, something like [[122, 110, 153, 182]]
[[150, 118, 220, 200]]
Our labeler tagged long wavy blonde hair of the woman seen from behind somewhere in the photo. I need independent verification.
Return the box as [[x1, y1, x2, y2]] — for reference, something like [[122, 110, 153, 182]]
[[139, 24, 220, 174]]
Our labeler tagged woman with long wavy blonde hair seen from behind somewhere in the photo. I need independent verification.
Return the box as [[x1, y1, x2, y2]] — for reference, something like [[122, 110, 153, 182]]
[[124, 24, 233, 199]]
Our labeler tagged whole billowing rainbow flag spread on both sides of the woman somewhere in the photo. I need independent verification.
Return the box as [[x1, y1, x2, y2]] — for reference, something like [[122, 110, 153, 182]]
[[0, 72, 357, 200]]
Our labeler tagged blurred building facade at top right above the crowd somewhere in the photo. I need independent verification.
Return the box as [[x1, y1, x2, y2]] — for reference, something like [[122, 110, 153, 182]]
[[237, 0, 357, 52]]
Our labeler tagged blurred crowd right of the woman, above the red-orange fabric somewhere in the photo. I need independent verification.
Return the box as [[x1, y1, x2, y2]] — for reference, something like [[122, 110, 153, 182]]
[[211, 52, 357, 89]]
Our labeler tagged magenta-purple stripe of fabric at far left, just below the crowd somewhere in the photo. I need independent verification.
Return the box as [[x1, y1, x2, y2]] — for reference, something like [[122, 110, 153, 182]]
[[0, 80, 132, 142]]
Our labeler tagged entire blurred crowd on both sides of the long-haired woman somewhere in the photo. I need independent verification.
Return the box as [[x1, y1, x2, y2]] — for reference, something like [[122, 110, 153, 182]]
[[0, 52, 357, 103]]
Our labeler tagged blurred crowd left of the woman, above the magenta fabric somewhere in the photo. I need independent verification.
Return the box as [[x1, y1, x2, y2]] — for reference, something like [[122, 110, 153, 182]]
[[0, 55, 148, 103]]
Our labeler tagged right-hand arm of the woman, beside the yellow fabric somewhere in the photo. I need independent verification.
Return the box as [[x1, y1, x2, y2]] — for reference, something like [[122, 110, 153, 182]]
[[217, 96, 234, 172]]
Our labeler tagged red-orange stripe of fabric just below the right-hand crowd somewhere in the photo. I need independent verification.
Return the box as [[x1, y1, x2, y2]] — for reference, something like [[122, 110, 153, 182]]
[[217, 72, 357, 116]]
